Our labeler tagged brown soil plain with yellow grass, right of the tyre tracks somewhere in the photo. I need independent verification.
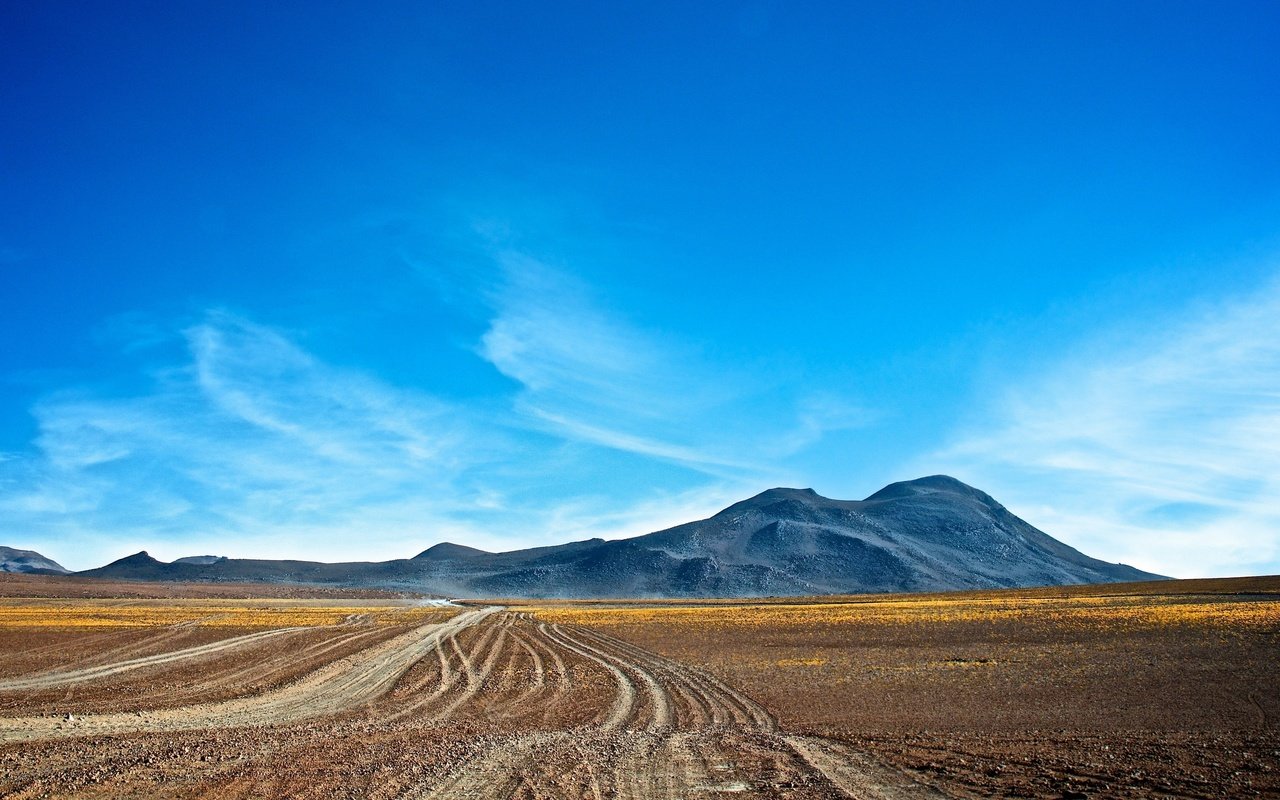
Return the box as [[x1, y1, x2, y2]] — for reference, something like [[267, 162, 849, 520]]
[[545, 577, 1280, 797]]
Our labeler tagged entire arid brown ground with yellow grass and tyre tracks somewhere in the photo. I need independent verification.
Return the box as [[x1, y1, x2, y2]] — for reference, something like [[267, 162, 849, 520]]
[[0, 576, 1280, 799]]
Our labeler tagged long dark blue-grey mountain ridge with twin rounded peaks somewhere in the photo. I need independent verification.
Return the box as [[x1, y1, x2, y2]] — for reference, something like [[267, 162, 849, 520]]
[[79, 475, 1161, 598]]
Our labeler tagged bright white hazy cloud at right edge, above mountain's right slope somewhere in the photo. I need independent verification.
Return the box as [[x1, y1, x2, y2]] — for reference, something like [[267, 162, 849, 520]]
[[920, 271, 1280, 576]]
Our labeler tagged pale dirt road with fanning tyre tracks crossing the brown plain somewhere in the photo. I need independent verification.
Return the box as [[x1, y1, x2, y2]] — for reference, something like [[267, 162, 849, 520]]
[[0, 607, 943, 800]]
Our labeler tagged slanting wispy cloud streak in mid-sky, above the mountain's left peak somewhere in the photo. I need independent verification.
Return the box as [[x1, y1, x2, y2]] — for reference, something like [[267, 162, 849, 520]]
[[465, 248, 874, 486]]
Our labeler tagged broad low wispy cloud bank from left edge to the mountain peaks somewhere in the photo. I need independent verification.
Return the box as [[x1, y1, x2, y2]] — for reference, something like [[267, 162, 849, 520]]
[[0, 304, 778, 568]]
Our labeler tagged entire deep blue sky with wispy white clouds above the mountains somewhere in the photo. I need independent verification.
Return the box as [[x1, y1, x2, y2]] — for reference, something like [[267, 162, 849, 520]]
[[0, 1, 1280, 576]]
